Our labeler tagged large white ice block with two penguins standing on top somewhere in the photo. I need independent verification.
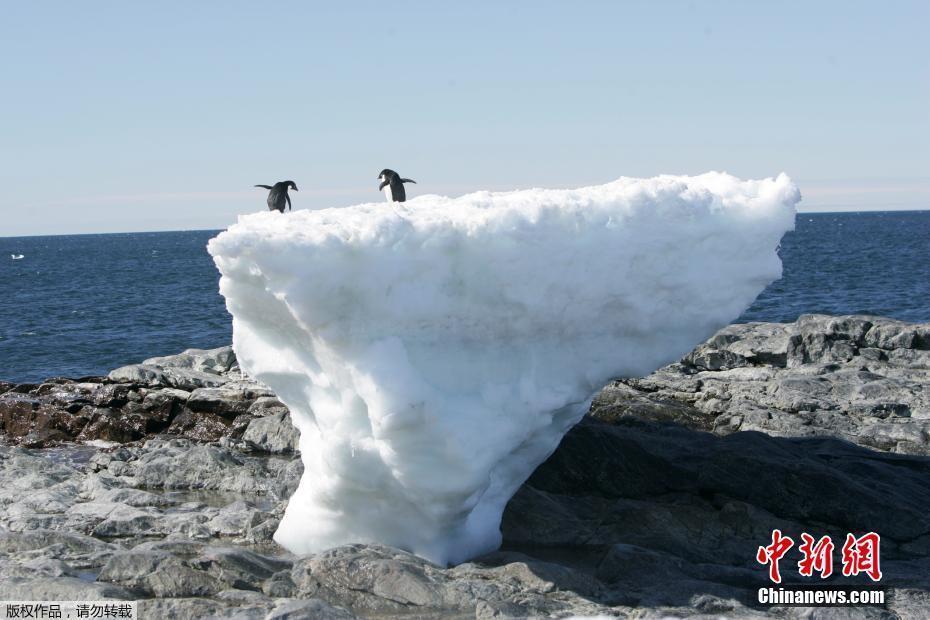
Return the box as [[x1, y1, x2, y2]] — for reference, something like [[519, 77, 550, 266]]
[[209, 173, 800, 564]]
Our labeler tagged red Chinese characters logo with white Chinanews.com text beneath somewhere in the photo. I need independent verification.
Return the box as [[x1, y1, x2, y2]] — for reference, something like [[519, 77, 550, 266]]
[[756, 529, 885, 607]]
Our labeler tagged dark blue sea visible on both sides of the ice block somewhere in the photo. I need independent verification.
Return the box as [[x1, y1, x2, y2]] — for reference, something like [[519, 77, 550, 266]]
[[0, 211, 930, 382]]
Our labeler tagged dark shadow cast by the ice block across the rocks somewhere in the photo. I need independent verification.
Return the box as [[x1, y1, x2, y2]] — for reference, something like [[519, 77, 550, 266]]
[[484, 418, 930, 612]]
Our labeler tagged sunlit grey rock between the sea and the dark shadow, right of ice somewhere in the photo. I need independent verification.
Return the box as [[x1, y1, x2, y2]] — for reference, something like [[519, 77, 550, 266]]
[[604, 315, 930, 454]]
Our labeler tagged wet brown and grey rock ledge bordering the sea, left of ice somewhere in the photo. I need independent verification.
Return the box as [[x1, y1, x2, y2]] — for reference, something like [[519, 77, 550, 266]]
[[0, 347, 278, 447]]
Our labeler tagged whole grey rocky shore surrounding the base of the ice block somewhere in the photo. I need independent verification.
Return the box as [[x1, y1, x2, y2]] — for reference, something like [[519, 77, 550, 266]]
[[0, 315, 930, 618]]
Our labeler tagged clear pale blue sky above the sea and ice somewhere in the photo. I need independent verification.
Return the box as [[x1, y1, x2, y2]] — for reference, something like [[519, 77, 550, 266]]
[[0, 0, 930, 236]]
